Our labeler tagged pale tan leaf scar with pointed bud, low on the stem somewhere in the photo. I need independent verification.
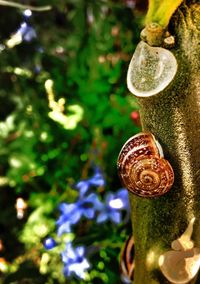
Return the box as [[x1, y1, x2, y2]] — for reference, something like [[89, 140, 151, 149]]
[[158, 218, 200, 284]]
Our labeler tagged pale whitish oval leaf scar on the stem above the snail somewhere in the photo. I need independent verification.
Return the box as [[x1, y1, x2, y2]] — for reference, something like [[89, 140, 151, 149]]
[[127, 41, 177, 97]]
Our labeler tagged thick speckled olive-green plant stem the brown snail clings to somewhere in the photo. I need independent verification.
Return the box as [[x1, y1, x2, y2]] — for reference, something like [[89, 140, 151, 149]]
[[129, 1, 200, 284]]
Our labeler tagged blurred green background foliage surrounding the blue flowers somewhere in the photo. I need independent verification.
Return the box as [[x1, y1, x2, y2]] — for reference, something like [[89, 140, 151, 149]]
[[0, 0, 144, 284]]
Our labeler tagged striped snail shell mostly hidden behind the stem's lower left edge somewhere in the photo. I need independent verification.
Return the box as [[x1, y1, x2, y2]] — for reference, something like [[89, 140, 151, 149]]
[[119, 236, 135, 284]]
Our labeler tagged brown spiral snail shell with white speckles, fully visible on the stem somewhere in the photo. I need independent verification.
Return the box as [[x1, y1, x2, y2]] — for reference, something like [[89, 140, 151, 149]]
[[117, 132, 174, 197]]
